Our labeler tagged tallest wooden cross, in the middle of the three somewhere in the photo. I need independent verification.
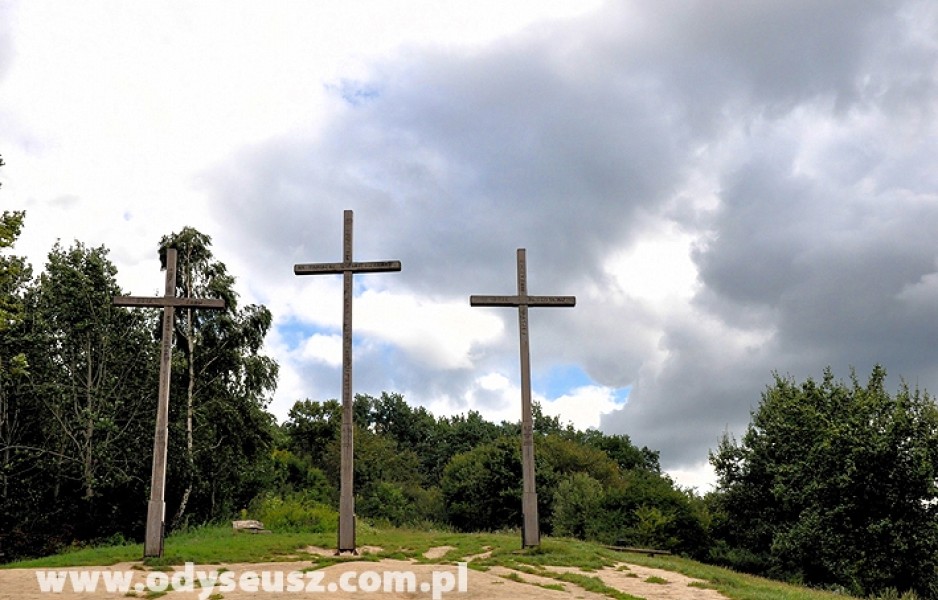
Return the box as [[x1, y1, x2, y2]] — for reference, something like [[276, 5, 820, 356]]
[[293, 210, 401, 554]]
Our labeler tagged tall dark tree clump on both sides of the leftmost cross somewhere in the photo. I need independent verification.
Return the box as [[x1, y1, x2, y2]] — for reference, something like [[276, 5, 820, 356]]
[[0, 224, 278, 558]]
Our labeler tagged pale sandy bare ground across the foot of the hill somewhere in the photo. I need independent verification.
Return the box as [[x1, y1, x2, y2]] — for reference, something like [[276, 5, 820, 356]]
[[0, 547, 725, 600]]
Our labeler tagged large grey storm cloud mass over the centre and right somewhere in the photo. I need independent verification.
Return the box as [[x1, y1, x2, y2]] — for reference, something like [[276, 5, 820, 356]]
[[209, 1, 938, 474]]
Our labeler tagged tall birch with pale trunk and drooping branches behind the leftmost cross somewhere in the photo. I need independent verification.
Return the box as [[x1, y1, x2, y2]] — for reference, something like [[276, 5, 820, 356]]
[[160, 227, 278, 526]]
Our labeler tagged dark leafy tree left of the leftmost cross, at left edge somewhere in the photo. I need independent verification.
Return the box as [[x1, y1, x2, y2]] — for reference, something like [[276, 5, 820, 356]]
[[0, 243, 156, 555]]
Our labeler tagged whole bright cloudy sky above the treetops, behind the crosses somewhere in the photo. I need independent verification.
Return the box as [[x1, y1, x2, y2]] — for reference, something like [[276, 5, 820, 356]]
[[0, 0, 938, 492]]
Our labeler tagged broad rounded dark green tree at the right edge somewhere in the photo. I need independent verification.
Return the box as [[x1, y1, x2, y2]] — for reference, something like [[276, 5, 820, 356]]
[[711, 366, 938, 598]]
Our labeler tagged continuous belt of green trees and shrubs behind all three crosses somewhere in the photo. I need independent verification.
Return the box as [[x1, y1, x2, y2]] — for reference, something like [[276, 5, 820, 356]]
[[0, 212, 699, 568]]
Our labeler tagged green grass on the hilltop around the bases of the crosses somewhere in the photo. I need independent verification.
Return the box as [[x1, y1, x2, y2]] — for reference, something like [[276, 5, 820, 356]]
[[0, 523, 856, 600]]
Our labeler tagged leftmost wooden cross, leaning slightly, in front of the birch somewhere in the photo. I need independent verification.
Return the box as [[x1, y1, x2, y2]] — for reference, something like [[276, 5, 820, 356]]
[[111, 248, 225, 557]]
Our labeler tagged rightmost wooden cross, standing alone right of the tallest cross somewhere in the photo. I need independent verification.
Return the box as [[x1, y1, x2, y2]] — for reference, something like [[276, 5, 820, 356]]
[[469, 248, 576, 548]]
